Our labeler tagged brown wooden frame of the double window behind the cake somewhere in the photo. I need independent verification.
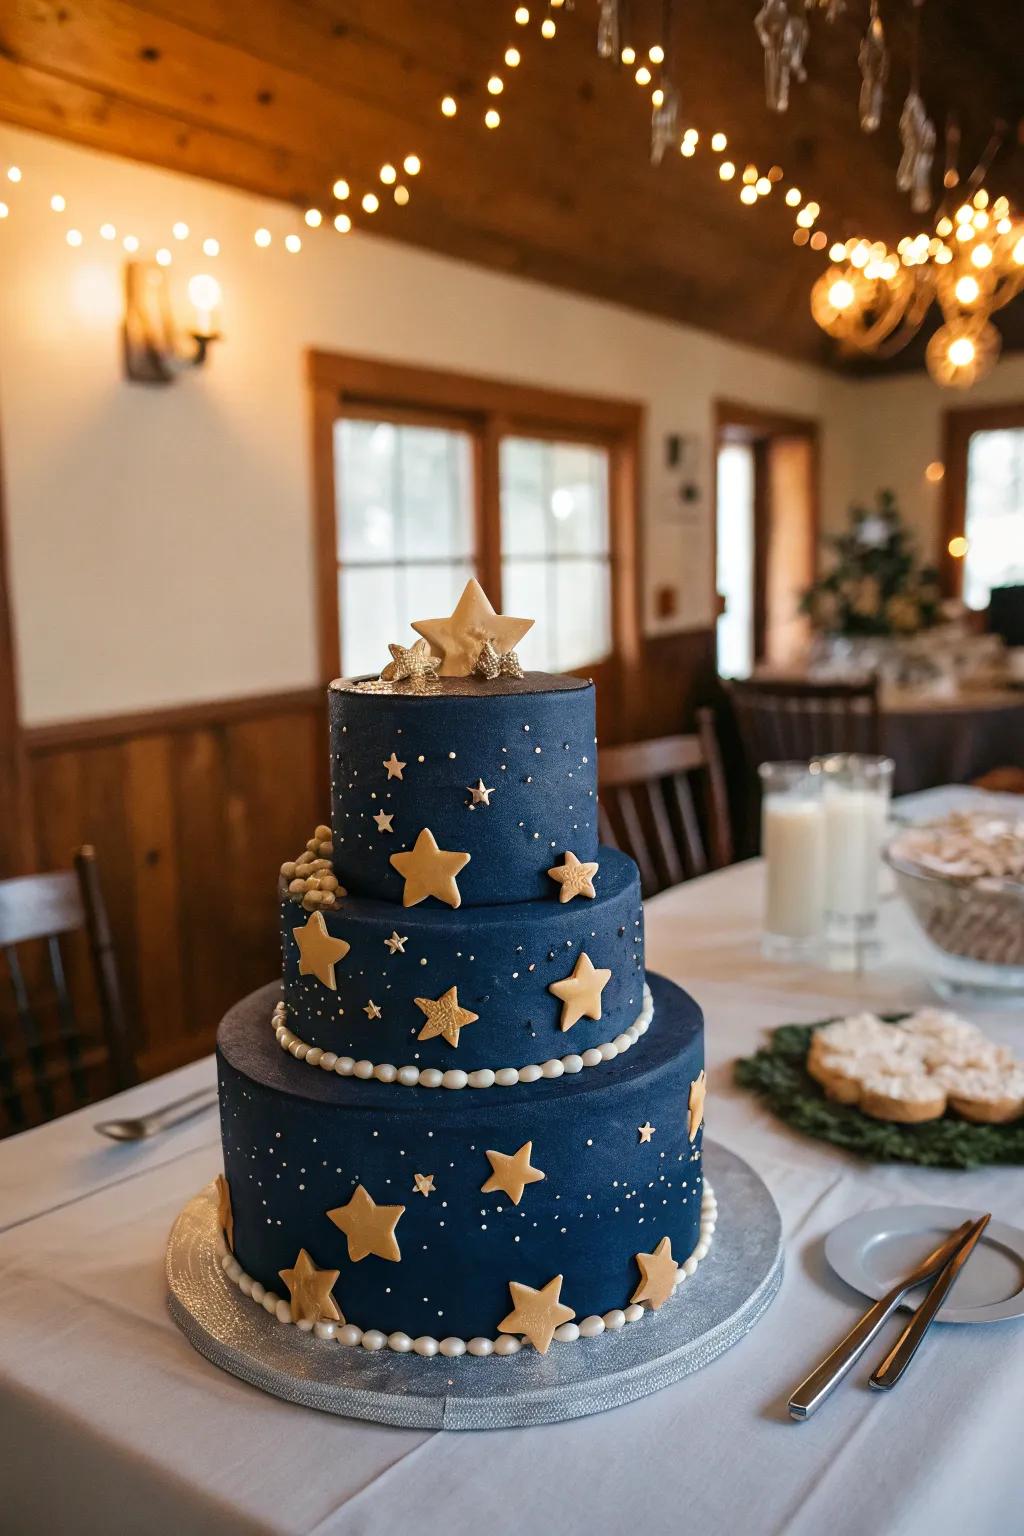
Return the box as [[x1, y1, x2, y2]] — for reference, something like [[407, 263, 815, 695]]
[[307, 352, 645, 696]]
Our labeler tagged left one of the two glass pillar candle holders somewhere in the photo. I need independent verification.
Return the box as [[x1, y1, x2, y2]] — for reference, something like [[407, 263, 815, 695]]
[[757, 762, 824, 960]]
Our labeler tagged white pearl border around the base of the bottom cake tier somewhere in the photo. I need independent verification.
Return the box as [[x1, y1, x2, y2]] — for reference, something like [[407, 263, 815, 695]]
[[221, 1180, 718, 1359]]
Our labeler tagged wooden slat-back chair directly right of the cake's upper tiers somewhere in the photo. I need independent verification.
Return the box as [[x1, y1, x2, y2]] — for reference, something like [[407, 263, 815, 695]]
[[597, 710, 732, 895]]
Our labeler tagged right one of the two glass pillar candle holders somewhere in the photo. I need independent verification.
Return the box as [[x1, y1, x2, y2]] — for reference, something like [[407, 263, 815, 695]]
[[811, 753, 894, 965]]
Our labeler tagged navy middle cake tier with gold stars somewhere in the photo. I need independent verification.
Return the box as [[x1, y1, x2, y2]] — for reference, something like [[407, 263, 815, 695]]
[[281, 848, 645, 1074]]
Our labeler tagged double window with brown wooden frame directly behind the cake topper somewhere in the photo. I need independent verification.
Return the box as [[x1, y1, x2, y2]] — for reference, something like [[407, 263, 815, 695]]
[[312, 353, 640, 677]]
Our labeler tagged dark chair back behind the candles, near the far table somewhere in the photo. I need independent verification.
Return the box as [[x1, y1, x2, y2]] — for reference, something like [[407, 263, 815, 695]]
[[726, 676, 881, 774]]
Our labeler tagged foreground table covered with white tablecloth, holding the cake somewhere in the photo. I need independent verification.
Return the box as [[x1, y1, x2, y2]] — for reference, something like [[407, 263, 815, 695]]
[[0, 835, 1024, 1536]]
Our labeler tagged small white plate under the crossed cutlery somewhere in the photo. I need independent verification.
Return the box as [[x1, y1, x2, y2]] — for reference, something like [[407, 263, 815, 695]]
[[824, 1206, 1024, 1322]]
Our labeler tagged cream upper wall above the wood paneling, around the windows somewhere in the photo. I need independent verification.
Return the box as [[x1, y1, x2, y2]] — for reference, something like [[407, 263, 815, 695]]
[[0, 129, 865, 723]]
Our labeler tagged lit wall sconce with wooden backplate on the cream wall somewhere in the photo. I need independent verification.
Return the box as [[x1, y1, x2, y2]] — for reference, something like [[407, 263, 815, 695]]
[[123, 261, 221, 384]]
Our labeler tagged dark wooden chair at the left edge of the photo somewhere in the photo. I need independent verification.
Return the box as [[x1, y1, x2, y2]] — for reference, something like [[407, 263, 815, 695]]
[[0, 846, 137, 1134]]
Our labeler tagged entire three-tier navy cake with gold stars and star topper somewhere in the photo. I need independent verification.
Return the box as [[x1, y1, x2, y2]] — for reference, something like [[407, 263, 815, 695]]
[[208, 582, 714, 1358]]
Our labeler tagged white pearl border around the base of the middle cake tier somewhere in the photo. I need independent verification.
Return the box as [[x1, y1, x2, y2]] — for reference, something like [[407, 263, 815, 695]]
[[270, 982, 654, 1089]]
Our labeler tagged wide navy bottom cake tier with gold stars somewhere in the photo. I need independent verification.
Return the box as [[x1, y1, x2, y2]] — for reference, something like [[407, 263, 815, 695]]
[[218, 977, 705, 1339]]
